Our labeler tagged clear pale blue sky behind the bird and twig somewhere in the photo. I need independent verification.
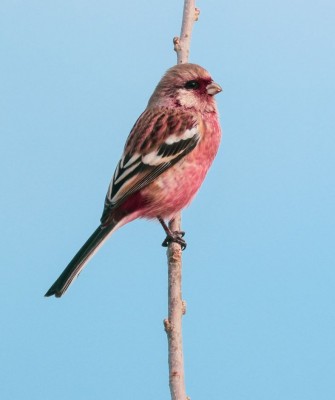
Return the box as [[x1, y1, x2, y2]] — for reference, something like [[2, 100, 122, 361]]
[[0, 0, 335, 400]]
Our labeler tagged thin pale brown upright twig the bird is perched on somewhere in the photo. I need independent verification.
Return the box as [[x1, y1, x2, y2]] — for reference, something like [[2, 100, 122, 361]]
[[164, 0, 200, 400]]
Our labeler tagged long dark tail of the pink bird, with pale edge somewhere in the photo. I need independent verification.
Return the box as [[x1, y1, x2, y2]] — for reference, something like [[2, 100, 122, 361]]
[[45, 222, 117, 297]]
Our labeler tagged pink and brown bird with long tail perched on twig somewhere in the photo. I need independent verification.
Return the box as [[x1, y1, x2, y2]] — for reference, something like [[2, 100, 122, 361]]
[[45, 63, 222, 297]]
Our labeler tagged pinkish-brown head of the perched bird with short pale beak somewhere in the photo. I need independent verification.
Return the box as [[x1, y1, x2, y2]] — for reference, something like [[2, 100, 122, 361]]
[[148, 64, 222, 112]]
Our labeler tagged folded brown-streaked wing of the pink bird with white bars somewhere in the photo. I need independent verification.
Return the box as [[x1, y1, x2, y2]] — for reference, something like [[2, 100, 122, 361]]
[[101, 109, 201, 222]]
